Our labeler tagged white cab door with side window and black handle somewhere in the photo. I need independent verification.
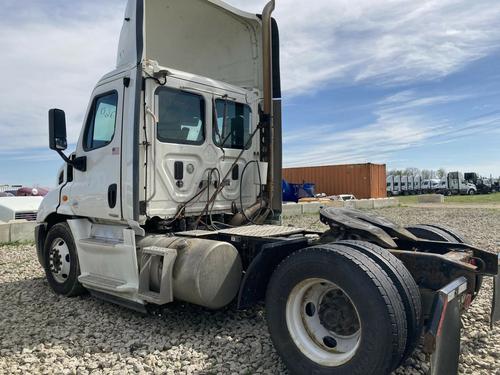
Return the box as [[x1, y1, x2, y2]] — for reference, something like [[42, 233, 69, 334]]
[[68, 78, 125, 220]]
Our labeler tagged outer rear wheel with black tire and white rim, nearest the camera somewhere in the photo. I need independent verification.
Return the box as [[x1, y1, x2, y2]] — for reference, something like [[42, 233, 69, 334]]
[[266, 244, 407, 375]]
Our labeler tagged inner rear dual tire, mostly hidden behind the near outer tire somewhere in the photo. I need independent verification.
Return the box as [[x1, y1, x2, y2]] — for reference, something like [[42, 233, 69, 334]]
[[336, 241, 424, 365]]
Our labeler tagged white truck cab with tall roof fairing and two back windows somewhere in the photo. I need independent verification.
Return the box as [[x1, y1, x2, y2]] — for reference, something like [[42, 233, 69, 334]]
[[39, 0, 281, 229]]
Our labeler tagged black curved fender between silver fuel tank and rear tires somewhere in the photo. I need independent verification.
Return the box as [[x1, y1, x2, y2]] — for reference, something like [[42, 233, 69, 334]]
[[237, 238, 309, 310]]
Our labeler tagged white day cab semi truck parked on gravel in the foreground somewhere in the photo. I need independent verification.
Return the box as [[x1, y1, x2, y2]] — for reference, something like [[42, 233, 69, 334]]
[[35, 0, 500, 375]]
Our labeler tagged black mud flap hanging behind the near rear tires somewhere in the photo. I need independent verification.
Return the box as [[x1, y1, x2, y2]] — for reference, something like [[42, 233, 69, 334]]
[[424, 277, 467, 375]]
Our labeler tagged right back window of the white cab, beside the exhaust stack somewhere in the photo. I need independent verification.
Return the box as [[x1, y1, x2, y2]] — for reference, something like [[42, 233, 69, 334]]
[[213, 99, 252, 149]]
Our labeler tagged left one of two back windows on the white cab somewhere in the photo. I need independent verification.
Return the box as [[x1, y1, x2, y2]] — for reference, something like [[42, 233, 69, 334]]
[[156, 87, 205, 145]]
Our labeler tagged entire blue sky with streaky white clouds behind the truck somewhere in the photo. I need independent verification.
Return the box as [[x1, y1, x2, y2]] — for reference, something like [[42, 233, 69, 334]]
[[0, 0, 500, 186]]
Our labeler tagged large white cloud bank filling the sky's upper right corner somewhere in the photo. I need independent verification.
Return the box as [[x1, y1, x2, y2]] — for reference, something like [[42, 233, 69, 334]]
[[229, 0, 500, 95]]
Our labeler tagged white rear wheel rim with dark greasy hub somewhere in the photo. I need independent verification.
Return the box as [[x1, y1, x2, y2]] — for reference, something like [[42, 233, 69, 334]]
[[286, 278, 361, 367]]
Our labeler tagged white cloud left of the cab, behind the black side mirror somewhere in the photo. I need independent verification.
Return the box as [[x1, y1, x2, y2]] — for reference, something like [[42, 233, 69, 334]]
[[0, 2, 124, 154]]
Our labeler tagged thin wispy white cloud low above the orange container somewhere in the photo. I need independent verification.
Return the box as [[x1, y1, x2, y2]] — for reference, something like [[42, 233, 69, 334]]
[[284, 91, 500, 167]]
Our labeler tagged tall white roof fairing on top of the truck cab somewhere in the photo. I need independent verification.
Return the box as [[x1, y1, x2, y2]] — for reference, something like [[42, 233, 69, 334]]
[[117, 0, 263, 90]]
